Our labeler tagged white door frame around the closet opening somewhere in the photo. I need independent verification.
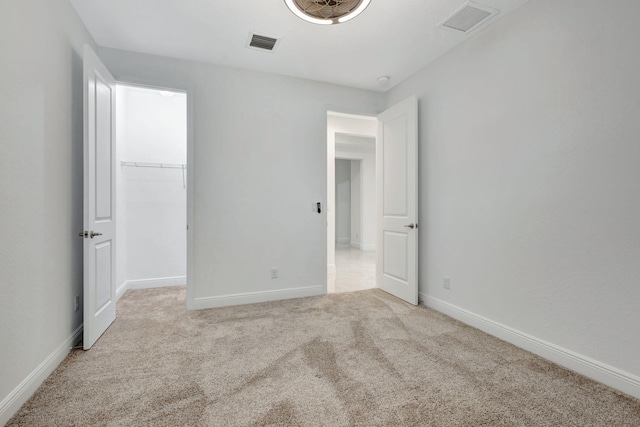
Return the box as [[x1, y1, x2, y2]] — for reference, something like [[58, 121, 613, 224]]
[[111, 78, 195, 310]]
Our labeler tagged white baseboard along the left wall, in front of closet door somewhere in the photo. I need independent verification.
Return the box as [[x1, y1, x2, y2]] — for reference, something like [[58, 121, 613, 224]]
[[0, 325, 82, 425]]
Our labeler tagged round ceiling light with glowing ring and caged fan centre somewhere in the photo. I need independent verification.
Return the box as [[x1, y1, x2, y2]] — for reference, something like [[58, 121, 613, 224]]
[[284, 0, 371, 25]]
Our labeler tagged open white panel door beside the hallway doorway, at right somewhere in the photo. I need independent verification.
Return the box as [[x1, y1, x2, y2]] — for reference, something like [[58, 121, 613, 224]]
[[376, 96, 418, 304]]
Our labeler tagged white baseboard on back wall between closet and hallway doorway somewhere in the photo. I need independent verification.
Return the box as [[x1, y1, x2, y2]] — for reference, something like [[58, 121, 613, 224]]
[[193, 286, 327, 310]]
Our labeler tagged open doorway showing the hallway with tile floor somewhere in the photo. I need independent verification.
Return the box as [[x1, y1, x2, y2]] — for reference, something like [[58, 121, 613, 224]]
[[327, 112, 377, 293]]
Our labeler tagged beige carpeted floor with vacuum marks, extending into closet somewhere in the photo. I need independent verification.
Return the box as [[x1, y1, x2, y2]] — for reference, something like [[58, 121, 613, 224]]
[[8, 287, 640, 426]]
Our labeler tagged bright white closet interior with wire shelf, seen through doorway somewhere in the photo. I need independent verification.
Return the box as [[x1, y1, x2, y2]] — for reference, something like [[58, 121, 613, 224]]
[[115, 84, 188, 298]]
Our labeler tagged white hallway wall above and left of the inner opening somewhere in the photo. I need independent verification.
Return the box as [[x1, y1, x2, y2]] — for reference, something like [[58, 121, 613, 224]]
[[326, 115, 381, 272]]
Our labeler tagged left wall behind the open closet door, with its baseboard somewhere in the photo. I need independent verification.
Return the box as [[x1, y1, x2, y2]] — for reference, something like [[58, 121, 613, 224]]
[[0, 0, 93, 425]]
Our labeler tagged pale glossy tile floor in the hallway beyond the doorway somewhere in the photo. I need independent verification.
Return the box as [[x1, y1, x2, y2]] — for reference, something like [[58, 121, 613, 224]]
[[327, 248, 376, 293]]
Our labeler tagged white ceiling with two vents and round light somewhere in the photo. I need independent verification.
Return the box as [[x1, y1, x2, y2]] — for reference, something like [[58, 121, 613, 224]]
[[70, 0, 527, 90]]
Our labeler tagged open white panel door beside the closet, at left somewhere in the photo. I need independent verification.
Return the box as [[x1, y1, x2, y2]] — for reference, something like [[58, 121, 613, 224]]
[[80, 45, 116, 350]]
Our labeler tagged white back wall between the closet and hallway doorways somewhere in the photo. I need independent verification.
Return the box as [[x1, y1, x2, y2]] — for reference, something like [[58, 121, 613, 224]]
[[99, 49, 383, 308]]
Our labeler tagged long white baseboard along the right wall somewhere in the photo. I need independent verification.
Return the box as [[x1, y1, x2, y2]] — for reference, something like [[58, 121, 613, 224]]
[[420, 293, 640, 398]]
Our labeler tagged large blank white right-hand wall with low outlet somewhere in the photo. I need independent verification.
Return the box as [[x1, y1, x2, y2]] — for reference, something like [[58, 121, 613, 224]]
[[387, 0, 640, 396]]
